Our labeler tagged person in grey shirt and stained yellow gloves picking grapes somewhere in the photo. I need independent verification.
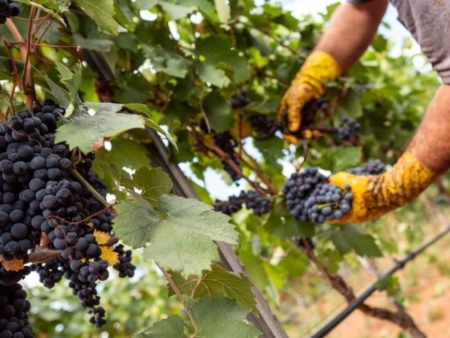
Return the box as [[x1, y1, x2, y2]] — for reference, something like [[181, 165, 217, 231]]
[[278, 0, 450, 224]]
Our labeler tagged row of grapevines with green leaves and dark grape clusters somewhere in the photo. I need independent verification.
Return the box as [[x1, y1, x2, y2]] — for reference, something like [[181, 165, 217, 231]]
[[0, 0, 446, 338]]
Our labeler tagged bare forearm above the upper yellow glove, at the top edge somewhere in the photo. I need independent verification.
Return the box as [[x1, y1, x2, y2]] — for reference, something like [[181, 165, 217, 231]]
[[315, 0, 387, 73]]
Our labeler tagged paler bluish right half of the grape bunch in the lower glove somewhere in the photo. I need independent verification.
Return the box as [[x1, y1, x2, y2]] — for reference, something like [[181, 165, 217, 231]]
[[305, 184, 353, 224]]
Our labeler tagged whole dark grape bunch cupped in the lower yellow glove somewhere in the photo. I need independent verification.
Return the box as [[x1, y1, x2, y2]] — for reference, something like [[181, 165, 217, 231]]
[[283, 168, 353, 223]]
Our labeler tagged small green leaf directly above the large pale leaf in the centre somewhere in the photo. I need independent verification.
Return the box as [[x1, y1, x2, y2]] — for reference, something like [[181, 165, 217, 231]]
[[123, 167, 173, 206]]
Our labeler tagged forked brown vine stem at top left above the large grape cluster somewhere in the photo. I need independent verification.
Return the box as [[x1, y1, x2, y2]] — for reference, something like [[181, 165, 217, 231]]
[[6, 18, 35, 109]]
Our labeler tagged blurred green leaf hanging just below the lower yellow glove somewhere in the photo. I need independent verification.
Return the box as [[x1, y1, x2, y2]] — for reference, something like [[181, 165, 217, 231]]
[[330, 224, 382, 257]]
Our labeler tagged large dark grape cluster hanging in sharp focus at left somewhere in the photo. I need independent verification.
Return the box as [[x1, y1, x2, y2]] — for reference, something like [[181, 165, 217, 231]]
[[0, 100, 134, 337]]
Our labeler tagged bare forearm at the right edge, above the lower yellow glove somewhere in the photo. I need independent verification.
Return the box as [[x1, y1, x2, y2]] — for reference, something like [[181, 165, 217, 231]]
[[408, 85, 450, 174]]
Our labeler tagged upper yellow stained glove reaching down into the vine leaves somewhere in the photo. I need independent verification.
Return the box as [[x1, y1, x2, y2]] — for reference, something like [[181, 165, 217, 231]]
[[278, 51, 341, 144]]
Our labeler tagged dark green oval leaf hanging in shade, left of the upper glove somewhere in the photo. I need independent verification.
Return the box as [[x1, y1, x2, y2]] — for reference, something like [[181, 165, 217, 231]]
[[203, 91, 233, 133]]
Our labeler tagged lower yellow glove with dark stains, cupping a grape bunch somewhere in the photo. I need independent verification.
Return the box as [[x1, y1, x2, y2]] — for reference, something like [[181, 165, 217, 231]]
[[329, 152, 437, 224]]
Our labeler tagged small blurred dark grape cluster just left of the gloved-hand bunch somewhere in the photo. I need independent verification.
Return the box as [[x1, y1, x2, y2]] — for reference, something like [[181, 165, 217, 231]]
[[214, 190, 271, 216]]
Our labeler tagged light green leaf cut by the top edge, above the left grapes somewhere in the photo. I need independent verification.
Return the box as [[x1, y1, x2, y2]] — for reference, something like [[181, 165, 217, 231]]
[[74, 0, 119, 35]]
